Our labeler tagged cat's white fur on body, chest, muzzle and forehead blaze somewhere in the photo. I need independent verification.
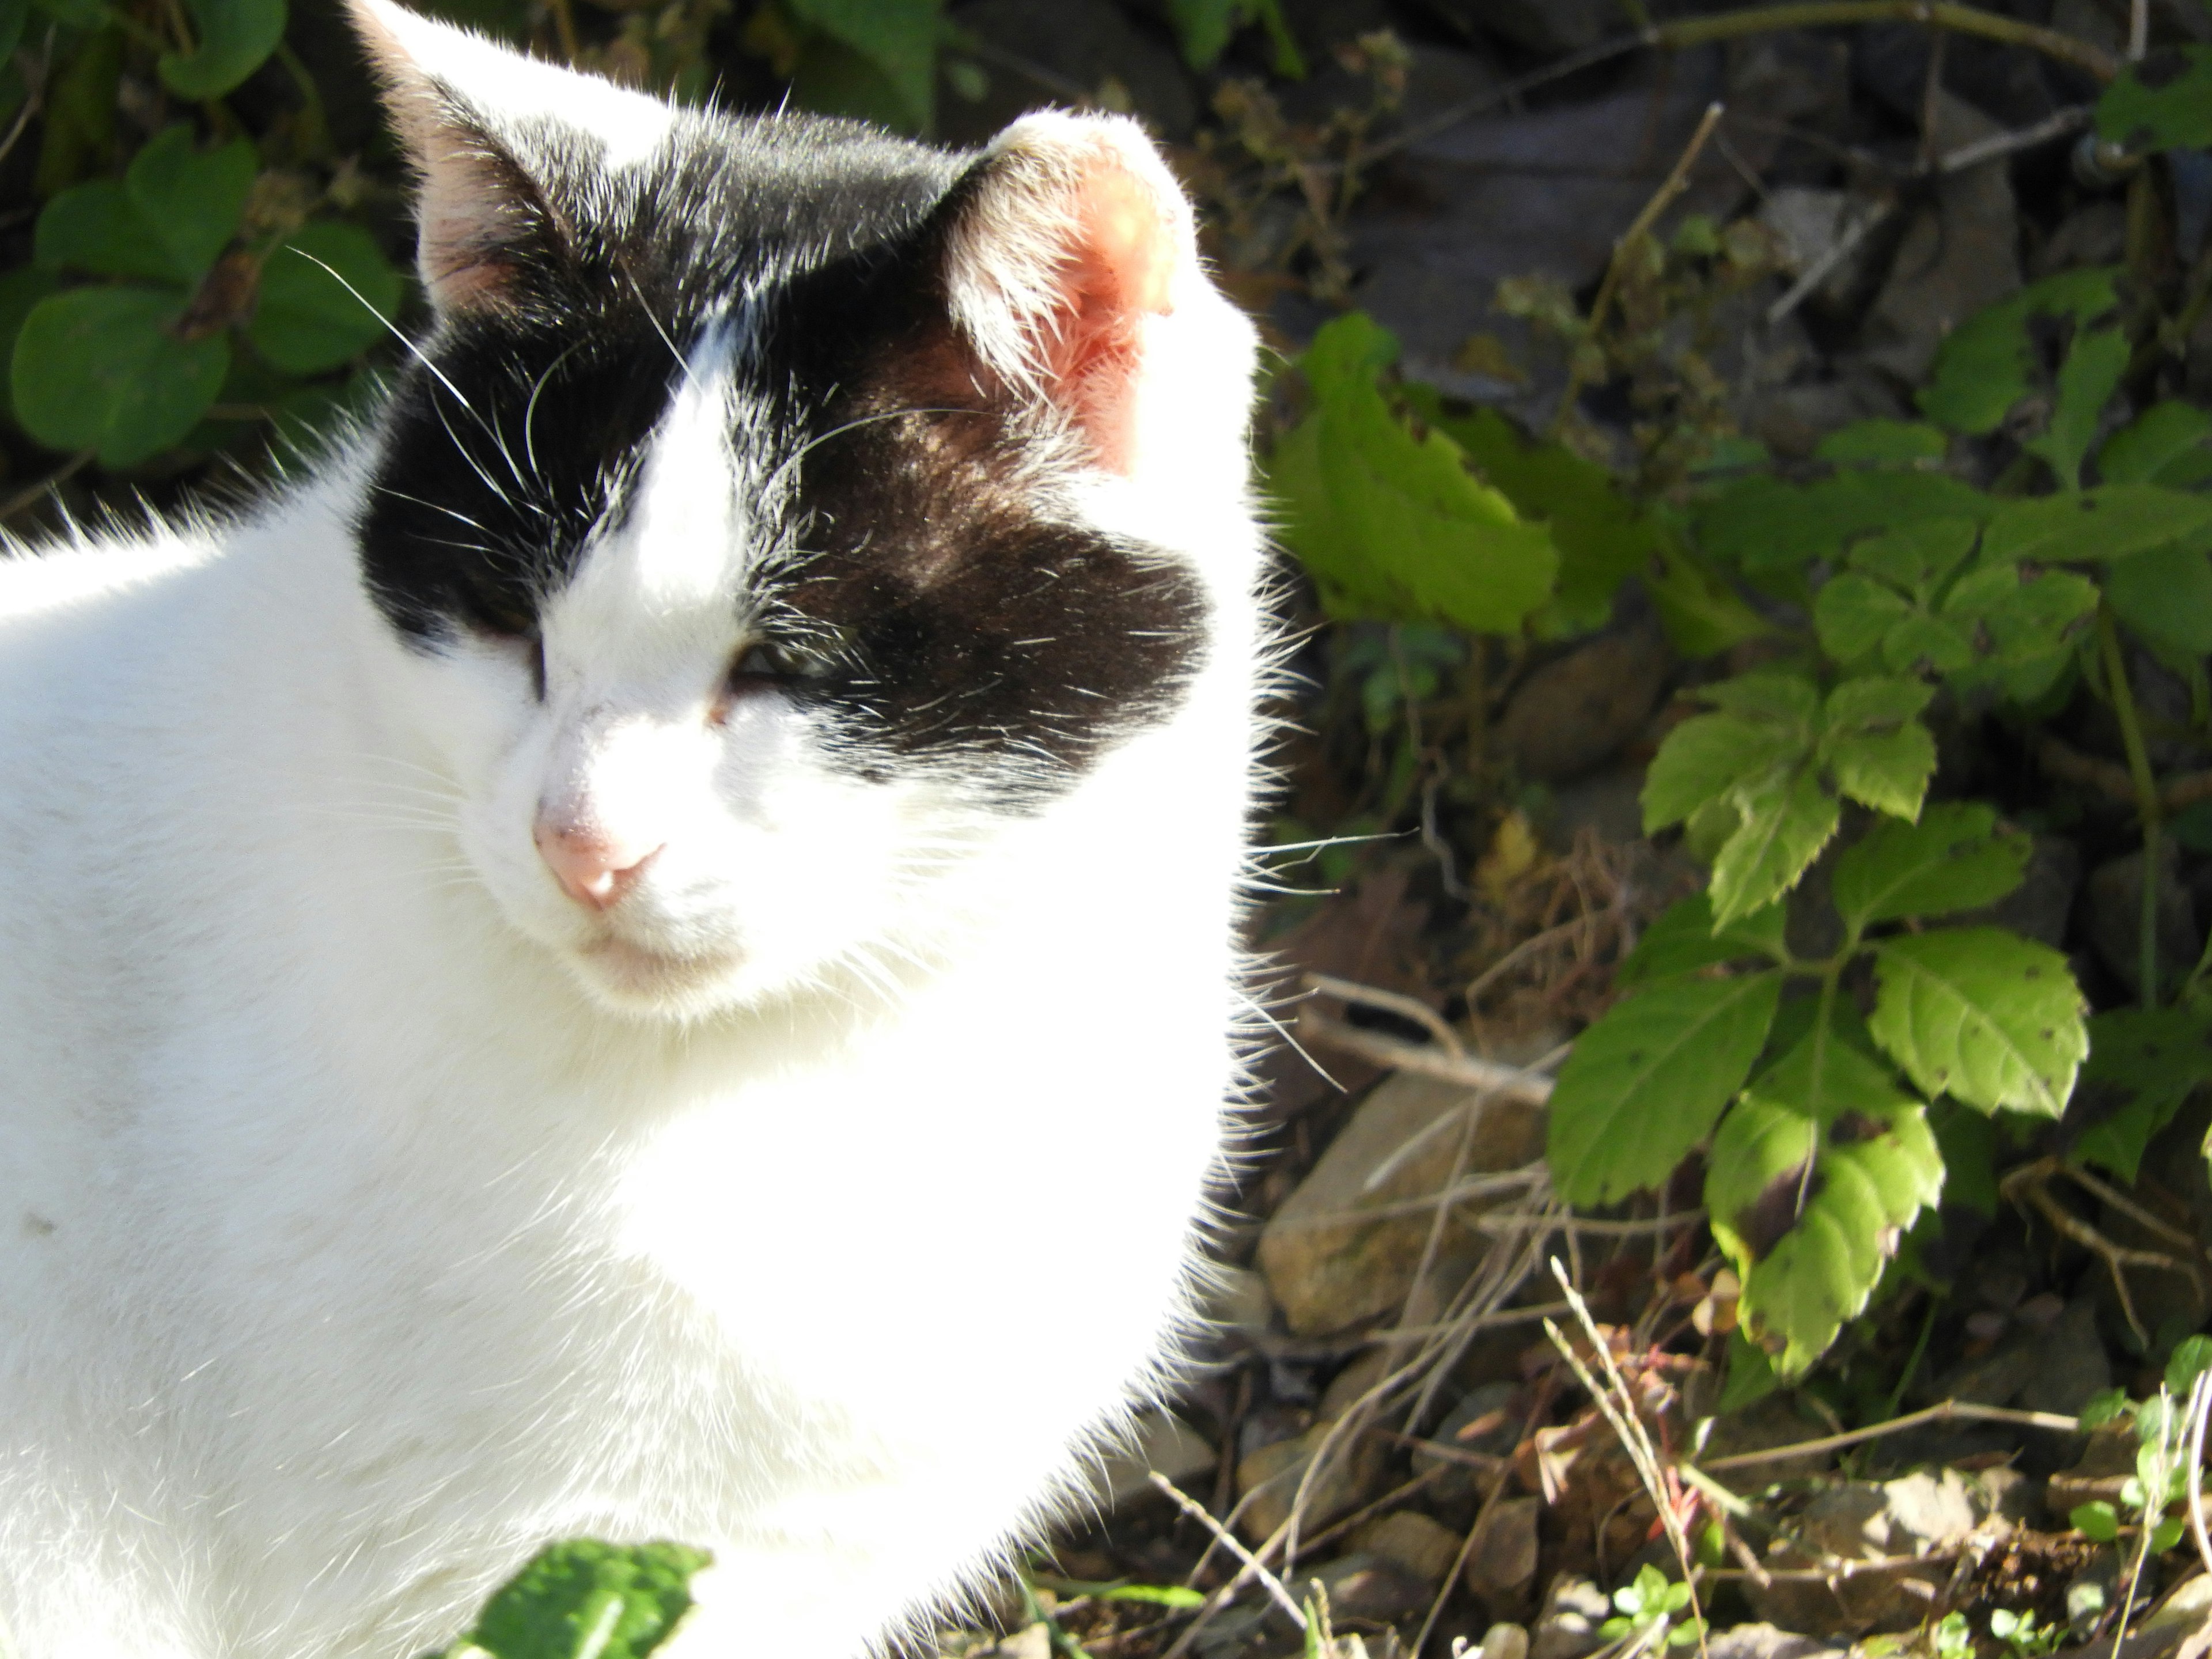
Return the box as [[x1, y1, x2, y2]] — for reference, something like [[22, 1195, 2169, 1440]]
[[0, 48, 1261, 1659]]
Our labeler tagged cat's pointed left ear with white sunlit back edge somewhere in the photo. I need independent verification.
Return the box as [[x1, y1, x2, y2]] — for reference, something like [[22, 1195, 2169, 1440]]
[[347, 0, 671, 316]]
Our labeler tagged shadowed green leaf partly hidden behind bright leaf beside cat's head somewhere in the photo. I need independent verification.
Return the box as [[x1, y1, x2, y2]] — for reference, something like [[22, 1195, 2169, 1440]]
[[1404, 385, 1663, 643]]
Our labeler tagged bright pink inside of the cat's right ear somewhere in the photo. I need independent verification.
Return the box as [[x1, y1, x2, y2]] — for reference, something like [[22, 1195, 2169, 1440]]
[[1042, 161, 1175, 474]]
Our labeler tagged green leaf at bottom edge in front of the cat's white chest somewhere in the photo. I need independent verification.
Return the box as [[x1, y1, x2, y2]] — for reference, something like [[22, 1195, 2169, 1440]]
[[467, 1540, 710, 1659]]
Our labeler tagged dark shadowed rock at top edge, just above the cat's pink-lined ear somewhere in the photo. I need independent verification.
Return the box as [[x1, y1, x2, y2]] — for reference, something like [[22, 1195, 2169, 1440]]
[[938, 0, 1199, 144]]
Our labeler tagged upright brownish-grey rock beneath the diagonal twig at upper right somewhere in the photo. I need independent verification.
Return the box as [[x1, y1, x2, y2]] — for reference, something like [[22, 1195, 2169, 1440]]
[[1865, 93, 2020, 380]]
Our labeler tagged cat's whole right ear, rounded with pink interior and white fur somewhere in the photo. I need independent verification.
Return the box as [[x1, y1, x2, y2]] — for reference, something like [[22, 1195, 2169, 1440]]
[[945, 113, 1206, 471]]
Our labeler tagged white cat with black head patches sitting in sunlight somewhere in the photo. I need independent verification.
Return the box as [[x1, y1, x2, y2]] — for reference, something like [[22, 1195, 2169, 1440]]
[[0, 0, 1272, 1659]]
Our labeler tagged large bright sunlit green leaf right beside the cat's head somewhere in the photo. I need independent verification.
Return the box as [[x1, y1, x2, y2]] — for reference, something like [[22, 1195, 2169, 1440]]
[[1274, 312, 1559, 632]]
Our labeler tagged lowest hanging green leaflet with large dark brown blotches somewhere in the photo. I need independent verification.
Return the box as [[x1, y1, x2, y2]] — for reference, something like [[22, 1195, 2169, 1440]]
[[1706, 1024, 1944, 1376]]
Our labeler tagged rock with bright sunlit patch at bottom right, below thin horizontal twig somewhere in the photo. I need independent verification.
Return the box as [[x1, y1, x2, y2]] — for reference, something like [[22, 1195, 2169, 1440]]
[[1743, 1469, 1988, 1635]]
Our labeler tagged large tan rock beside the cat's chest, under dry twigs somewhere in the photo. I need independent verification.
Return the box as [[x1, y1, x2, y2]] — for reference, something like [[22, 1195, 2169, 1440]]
[[1259, 1073, 1544, 1336]]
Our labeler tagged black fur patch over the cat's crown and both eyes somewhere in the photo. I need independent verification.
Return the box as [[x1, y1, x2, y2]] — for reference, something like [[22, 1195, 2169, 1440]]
[[358, 104, 1206, 803]]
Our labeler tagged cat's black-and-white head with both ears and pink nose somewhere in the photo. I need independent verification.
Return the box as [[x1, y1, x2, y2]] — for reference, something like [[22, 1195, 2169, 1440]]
[[354, 0, 1252, 1017]]
